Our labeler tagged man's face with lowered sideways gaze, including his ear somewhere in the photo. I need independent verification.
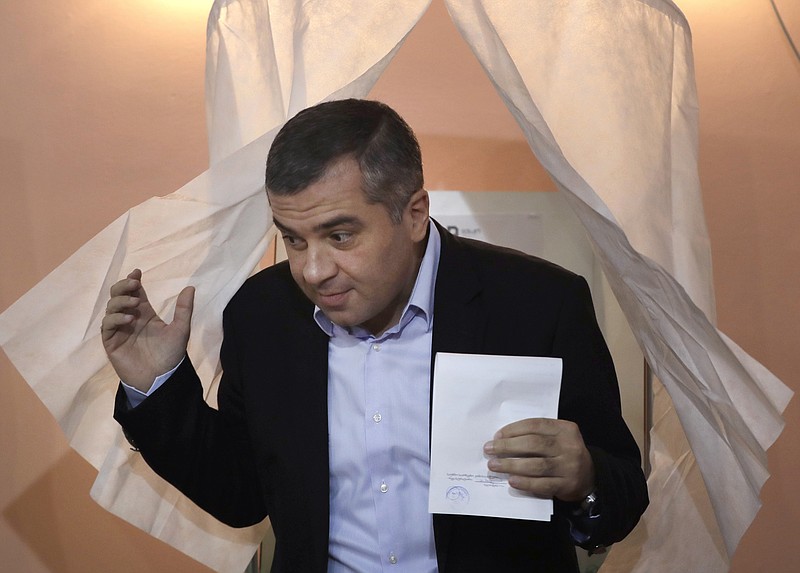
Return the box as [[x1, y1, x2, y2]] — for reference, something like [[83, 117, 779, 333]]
[[269, 159, 428, 335]]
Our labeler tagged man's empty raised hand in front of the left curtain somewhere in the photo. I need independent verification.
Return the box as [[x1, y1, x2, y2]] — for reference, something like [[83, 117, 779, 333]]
[[101, 269, 194, 392]]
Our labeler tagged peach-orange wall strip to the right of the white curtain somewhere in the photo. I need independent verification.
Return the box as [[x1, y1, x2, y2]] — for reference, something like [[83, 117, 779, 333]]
[[679, 0, 800, 573]]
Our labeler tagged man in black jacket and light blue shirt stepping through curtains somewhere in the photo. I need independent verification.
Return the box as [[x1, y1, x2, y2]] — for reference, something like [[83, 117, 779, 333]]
[[103, 96, 647, 573]]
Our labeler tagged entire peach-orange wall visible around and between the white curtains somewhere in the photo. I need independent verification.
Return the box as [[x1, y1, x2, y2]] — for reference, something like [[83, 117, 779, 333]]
[[0, 0, 800, 573]]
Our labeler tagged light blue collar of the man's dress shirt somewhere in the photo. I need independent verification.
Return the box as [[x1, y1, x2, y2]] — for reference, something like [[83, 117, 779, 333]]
[[314, 221, 442, 338]]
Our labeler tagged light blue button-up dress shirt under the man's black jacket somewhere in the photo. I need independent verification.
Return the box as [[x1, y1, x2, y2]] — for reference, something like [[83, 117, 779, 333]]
[[314, 225, 441, 573]]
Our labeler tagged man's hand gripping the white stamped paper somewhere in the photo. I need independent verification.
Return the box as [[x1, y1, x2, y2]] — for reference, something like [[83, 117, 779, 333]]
[[483, 418, 595, 501]]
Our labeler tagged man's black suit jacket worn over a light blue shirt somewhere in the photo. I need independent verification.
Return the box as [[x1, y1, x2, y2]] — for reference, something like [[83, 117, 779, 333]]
[[115, 221, 647, 573]]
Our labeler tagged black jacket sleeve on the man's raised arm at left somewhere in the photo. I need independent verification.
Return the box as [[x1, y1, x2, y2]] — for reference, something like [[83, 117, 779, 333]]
[[114, 310, 267, 527]]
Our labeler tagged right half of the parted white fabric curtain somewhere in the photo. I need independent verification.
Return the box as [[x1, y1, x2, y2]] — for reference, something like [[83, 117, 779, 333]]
[[445, 0, 791, 572]]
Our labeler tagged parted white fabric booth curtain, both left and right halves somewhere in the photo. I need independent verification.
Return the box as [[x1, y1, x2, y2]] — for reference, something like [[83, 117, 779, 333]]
[[0, 0, 791, 573]]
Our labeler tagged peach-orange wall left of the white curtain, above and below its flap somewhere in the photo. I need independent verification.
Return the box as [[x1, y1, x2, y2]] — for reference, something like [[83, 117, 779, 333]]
[[0, 0, 216, 573]]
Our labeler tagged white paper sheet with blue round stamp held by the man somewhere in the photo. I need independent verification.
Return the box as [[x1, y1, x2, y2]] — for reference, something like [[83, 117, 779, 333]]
[[428, 352, 561, 521]]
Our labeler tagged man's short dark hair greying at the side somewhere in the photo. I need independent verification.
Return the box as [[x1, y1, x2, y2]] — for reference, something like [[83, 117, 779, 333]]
[[266, 99, 424, 223]]
